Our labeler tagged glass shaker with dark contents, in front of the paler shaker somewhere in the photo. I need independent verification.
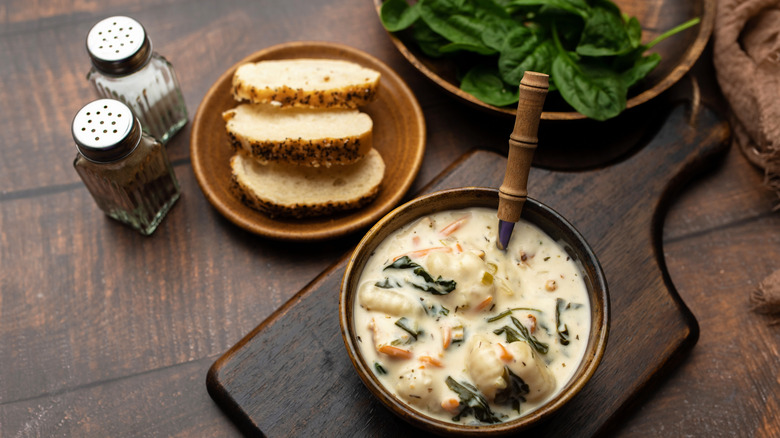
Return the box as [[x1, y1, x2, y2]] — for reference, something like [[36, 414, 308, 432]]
[[71, 99, 180, 235]]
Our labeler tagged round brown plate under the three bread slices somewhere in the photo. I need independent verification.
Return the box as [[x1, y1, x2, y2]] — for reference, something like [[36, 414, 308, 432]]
[[190, 42, 425, 240]]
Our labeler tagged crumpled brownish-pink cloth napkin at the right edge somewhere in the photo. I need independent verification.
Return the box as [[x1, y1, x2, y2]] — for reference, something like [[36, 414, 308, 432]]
[[713, 0, 780, 324]]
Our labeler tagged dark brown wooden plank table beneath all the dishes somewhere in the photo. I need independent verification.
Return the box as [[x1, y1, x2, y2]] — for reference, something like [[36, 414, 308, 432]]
[[0, 0, 780, 437]]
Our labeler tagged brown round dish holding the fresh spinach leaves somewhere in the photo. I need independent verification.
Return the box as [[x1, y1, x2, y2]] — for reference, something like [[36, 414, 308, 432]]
[[374, 0, 715, 120]]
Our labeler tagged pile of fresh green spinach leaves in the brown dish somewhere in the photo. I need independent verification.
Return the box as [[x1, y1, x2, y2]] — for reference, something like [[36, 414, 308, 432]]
[[380, 0, 700, 120]]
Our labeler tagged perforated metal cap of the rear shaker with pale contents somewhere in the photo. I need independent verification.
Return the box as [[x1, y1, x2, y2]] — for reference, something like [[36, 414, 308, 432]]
[[87, 16, 152, 75]]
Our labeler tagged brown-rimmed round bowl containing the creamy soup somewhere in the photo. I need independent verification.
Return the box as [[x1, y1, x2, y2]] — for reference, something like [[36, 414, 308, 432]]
[[339, 187, 609, 436]]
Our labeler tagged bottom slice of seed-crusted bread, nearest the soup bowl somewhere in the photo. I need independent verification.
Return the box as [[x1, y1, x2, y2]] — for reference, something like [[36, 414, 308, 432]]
[[230, 149, 385, 218]]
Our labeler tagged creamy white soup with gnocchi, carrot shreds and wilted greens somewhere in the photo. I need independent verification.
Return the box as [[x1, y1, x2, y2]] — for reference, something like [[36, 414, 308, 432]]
[[354, 208, 590, 424]]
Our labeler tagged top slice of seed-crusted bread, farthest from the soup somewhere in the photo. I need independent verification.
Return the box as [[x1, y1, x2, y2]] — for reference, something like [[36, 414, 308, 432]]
[[233, 59, 380, 108]]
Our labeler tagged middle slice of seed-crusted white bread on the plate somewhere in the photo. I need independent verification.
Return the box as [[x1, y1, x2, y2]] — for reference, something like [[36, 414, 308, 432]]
[[222, 104, 373, 167]]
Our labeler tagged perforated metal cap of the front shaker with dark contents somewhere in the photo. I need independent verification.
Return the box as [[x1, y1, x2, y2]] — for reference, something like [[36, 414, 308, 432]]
[[71, 99, 141, 163]]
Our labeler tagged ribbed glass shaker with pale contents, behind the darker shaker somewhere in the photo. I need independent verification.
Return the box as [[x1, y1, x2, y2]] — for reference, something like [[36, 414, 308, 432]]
[[87, 16, 187, 144]]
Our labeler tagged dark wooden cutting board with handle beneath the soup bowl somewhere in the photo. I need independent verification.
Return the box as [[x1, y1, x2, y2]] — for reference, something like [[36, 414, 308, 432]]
[[207, 104, 730, 437]]
